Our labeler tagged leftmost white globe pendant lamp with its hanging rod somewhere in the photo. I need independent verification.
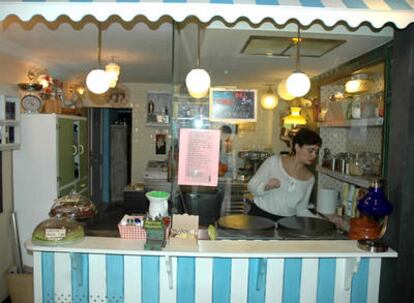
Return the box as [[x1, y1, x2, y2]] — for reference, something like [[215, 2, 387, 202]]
[[86, 23, 111, 95]]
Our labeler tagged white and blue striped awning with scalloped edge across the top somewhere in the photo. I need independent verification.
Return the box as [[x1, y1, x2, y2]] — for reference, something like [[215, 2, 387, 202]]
[[0, 0, 414, 28]]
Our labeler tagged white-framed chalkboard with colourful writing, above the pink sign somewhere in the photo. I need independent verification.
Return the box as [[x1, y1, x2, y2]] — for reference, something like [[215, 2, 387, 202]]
[[209, 88, 257, 124]]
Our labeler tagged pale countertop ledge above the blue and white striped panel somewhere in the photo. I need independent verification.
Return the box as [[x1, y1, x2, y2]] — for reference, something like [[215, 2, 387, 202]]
[[25, 237, 398, 258]]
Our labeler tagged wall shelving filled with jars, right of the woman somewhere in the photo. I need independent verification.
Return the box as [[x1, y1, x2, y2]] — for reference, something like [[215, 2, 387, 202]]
[[316, 58, 387, 226]]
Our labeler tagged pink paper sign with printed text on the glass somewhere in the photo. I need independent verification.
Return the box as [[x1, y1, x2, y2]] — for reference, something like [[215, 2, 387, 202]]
[[178, 128, 220, 186]]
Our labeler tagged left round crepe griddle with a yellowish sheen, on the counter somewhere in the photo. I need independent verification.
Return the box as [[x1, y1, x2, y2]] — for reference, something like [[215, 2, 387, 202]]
[[217, 214, 275, 236]]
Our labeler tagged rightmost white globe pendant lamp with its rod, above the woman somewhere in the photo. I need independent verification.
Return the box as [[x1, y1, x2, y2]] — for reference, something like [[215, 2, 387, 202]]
[[286, 25, 311, 97]]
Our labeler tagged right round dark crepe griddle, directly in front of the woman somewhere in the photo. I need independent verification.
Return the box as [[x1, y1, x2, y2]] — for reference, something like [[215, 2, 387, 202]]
[[277, 217, 336, 236]]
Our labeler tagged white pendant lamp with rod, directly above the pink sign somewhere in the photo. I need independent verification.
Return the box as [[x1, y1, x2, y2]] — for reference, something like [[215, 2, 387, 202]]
[[185, 26, 211, 98]]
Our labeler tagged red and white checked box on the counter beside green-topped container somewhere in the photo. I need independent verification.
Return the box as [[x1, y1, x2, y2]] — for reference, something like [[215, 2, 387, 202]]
[[118, 215, 171, 240]]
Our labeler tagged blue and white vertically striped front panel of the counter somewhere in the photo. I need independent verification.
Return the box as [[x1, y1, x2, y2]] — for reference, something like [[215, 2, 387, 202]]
[[34, 251, 381, 303]]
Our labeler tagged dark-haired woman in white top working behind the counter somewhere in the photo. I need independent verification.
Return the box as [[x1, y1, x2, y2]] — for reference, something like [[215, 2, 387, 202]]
[[248, 128, 322, 221]]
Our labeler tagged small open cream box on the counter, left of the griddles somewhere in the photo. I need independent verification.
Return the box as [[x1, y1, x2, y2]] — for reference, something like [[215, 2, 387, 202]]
[[169, 214, 199, 247]]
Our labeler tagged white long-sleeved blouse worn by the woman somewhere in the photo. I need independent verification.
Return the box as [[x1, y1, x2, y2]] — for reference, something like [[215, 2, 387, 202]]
[[248, 155, 315, 217]]
